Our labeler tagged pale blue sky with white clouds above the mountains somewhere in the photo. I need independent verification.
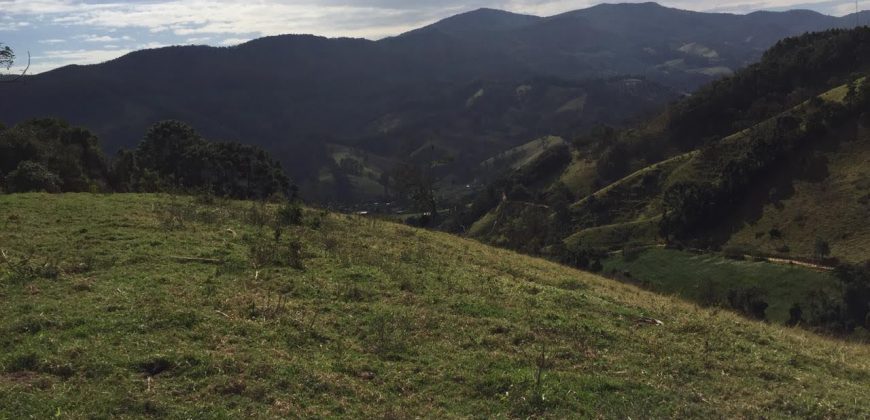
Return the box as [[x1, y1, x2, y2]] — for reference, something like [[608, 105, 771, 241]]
[[0, 0, 870, 74]]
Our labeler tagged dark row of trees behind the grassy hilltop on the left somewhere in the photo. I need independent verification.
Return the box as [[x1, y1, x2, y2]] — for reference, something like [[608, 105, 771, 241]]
[[0, 118, 295, 199]]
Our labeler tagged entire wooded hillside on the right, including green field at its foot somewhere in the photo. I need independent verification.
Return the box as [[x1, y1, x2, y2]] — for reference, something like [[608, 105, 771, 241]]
[[449, 28, 870, 331]]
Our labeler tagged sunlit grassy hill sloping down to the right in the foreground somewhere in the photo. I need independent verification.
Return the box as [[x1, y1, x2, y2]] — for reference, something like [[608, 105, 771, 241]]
[[0, 194, 870, 418]]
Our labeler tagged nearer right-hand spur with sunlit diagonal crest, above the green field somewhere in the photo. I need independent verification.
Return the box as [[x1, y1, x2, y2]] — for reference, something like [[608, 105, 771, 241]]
[[470, 78, 870, 263]]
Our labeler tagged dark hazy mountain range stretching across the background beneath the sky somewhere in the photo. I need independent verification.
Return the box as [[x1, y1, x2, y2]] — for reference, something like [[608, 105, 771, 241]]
[[0, 3, 864, 202]]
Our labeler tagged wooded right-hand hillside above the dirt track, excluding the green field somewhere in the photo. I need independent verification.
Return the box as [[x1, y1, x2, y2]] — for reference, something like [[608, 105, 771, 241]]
[[472, 28, 870, 256]]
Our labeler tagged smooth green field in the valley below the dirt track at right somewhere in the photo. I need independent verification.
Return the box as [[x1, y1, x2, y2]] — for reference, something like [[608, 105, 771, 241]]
[[603, 248, 839, 323]]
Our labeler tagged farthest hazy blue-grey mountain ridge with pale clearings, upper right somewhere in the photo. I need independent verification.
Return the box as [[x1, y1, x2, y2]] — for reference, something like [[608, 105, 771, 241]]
[[411, 3, 855, 91]]
